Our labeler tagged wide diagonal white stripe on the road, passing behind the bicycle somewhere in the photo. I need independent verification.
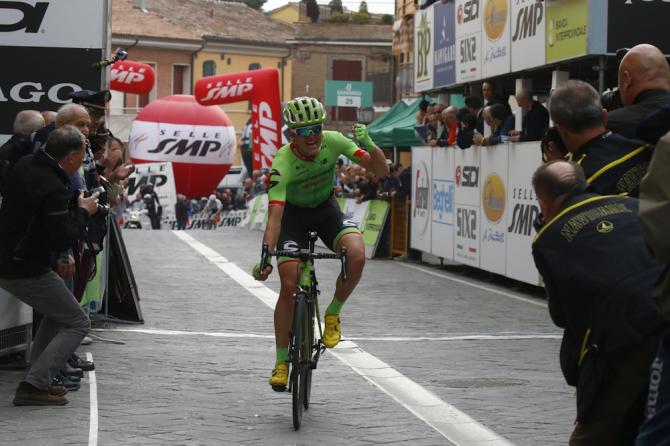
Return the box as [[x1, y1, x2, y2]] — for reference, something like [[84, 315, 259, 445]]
[[172, 231, 512, 446]]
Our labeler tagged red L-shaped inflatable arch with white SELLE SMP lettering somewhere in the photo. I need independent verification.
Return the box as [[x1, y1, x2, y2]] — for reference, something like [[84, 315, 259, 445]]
[[195, 68, 282, 169]]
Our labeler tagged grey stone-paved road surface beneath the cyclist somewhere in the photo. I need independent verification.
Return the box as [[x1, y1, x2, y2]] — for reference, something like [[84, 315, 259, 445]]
[[0, 229, 574, 445]]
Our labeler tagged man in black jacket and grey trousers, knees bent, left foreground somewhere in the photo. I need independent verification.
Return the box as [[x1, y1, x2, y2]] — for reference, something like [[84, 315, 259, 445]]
[[0, 126, 98, 405]]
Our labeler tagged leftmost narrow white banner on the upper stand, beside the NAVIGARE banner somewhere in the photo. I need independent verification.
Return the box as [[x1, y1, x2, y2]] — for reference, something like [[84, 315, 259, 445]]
[[414, 5, 435, 92]]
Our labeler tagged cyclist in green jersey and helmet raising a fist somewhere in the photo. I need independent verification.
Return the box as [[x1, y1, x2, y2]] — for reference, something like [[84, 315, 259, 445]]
[[253, 97, 388, 391]]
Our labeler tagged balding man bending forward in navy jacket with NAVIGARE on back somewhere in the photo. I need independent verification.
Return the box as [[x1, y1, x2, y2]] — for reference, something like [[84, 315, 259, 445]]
[[533, 161, 666, 445]]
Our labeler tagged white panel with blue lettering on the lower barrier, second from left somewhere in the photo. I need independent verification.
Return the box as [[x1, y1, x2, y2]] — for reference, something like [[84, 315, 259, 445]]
[[430, 147, 456, 260]]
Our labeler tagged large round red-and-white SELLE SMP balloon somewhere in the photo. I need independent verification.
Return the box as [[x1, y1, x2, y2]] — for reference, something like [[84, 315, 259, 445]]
[[128, 95, 237, 197]]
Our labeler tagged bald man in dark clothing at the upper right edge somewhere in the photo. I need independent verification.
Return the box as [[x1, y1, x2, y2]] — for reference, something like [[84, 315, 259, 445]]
[[608, 44, 670, 138]]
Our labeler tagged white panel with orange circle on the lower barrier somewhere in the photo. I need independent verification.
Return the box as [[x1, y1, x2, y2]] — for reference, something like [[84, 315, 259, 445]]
[[479, 144, 509, 275]]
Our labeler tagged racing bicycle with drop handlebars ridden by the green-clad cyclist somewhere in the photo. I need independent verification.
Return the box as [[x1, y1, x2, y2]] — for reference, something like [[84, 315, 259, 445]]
[[261, 232, 348, 430]]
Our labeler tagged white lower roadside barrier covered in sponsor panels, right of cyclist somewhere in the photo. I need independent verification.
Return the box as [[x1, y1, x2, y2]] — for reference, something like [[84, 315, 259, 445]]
[[414, 142, 542, 285]]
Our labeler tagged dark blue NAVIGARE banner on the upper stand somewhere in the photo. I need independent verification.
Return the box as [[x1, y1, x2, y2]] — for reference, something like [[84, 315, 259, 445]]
[[433, 2, 456, 87]]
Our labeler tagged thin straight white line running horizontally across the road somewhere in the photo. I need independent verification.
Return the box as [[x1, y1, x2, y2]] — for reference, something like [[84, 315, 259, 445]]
[[93, 328, 563, 342]]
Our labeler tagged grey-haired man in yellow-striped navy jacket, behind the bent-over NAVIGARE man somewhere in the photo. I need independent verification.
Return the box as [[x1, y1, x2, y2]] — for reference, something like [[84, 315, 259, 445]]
[[549, 80, 653, 197]]
